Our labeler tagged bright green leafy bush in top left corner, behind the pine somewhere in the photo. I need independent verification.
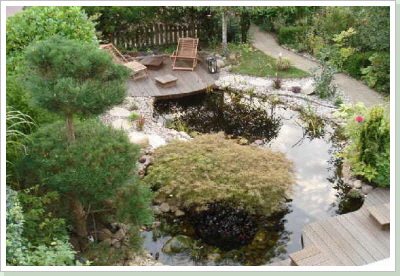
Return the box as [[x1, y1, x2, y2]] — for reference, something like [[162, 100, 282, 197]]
[[6, 6, 97, 55]]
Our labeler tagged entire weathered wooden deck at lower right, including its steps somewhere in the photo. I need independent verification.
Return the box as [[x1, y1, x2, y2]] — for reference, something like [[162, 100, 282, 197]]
[[269, 188, 390, 266]]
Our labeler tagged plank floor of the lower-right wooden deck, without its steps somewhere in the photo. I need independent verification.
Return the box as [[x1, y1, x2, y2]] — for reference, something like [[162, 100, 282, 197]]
[[269, 188, 390, 266]]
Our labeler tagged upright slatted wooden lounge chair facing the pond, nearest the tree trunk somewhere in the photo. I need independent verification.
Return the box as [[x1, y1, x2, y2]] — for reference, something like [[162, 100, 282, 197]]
[[171, 37, 199, 71]]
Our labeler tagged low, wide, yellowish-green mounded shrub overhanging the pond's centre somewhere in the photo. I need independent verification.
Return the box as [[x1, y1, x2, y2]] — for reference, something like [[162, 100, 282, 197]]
[[144, 134, 294, 215]]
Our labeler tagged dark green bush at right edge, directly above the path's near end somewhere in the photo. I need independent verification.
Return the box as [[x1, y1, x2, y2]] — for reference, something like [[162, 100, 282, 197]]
[[361, 53, 390, 93]]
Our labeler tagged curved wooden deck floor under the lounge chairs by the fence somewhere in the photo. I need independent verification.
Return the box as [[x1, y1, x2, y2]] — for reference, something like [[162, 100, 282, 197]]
[[128, 57, 219, 98]]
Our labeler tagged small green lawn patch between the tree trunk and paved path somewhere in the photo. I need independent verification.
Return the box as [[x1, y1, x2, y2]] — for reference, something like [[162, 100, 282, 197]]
[[231, 50, 310, 78]]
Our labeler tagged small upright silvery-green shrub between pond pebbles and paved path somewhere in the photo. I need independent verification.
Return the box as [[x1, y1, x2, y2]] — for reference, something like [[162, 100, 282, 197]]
[[311, 63, 336, 99]]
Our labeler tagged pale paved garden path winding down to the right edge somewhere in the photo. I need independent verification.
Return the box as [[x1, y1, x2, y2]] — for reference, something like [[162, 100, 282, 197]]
[[250, 24, 388, 107]]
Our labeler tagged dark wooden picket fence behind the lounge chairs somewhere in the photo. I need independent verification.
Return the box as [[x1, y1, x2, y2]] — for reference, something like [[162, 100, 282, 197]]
[[111, 24, 198, 50]]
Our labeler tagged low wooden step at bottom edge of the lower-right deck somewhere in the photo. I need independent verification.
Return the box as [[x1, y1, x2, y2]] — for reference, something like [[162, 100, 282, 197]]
[[289, 246, 337, 266]]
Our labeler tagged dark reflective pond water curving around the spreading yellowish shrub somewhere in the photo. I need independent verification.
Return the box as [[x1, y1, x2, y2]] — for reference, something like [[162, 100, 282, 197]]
[[142, 92, 362, 265]]
